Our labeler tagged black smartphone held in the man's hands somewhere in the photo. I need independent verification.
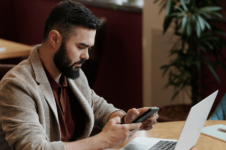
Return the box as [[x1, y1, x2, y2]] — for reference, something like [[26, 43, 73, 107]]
[[131, 107, 159, 123]]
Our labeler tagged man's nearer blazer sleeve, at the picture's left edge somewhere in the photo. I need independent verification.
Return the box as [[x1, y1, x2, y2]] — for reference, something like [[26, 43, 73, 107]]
[[0, 79, 65, 150]]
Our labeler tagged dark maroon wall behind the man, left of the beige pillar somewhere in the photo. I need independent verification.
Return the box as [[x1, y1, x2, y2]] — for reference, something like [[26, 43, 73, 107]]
[[0, 0, 142, 110]]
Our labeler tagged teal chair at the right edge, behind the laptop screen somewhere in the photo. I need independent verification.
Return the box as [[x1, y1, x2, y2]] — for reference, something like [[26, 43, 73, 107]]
[[209, 94, 226, 120]]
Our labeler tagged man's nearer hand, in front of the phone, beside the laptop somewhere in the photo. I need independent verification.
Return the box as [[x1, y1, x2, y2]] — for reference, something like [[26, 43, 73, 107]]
[[100, 117, 142, 148]]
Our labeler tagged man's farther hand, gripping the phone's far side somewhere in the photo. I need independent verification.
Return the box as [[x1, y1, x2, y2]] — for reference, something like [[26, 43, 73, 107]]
[[124, 107, 159, 130]]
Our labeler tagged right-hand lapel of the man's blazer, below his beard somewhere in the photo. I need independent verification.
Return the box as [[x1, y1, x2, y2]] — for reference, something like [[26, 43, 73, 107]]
[[68, 79, 94, 138]]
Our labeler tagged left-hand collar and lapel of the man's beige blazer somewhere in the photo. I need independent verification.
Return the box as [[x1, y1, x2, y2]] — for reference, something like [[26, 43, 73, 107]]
[[28, 45, 59, 123]]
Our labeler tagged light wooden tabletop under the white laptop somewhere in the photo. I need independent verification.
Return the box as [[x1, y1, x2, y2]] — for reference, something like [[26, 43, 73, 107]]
[[116, 121, 226, 150]]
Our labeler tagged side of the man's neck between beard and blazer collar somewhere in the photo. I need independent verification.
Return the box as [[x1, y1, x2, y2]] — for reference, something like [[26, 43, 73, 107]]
[[38, 44, 61, 84]]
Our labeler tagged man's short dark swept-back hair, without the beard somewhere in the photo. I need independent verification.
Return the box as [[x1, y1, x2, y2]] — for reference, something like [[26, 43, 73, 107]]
[[43, 0, 100, 42]]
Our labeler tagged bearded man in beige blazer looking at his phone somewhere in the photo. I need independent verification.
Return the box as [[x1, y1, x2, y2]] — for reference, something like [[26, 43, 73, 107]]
[[0, 0, 158, 150]]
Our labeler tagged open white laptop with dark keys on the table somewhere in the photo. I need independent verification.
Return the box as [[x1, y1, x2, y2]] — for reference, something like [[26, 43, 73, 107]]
[[120, 91, 218, 150]]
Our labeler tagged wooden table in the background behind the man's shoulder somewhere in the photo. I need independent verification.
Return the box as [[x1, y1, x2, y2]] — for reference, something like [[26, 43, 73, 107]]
[[0, 39, 32, 59]]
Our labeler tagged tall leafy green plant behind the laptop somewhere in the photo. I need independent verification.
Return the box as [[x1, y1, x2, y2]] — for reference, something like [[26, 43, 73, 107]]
[[155, 0, 226, 105]]
